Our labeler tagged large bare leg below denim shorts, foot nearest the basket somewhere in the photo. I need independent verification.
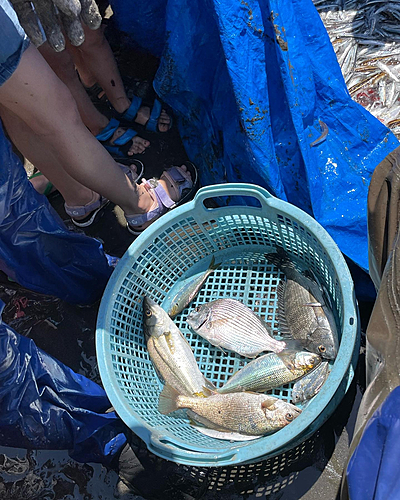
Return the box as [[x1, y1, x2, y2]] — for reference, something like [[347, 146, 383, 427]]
[[0, 46, 190, 225]]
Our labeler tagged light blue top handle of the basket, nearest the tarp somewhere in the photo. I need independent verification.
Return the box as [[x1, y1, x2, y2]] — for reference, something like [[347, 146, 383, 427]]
[[193, 182, 275, 210]]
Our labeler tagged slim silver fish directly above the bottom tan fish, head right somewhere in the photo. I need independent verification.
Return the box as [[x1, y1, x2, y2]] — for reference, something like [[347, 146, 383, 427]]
[[217, 350, 321, 394]]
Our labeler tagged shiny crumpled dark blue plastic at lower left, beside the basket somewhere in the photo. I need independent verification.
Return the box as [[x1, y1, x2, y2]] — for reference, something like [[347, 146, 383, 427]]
[[0, 300, 126, 464]]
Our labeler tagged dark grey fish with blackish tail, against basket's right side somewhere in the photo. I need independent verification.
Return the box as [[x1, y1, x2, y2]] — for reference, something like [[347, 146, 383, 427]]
[[265, 247, 339, 359]]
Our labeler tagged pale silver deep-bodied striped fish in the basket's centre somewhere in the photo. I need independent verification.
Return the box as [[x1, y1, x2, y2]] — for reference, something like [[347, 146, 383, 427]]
[[186, 299, 286, 358]]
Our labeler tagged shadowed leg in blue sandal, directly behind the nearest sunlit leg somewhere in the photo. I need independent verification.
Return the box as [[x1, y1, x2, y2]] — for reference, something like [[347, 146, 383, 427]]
[[39, 42, 150, 156]]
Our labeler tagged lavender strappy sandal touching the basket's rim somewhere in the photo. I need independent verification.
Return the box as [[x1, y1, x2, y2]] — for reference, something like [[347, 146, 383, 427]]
[[125, 162, 198, 236]]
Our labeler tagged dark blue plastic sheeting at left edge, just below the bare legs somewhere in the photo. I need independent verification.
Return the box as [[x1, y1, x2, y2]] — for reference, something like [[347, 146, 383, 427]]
[[0, 120, 112, 304]]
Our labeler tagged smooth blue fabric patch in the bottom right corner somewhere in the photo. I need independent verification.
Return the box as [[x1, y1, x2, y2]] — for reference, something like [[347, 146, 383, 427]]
[[347, 387, 400, 500]]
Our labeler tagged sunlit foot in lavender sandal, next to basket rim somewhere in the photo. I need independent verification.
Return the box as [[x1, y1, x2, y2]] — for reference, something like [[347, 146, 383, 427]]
[[126, 165, 193, 235]]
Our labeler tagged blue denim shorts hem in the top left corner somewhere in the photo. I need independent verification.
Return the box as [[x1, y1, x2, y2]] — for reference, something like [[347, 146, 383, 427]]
[[0, 0, 29, 85]]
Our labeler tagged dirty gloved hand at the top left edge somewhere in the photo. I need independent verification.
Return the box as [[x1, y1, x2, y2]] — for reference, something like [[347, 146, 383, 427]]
[[10, 0, 101, 52]]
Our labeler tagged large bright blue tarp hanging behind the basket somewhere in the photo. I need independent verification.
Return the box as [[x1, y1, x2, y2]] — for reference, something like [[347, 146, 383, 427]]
[[111, 0, 399, 270]]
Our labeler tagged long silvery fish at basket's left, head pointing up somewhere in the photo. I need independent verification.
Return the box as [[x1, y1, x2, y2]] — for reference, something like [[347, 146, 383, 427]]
[[143, 296, 215, 397]]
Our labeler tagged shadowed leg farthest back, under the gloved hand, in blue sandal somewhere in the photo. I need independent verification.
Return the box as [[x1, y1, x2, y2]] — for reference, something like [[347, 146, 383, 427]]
[[67, 27, 171, 132]]
